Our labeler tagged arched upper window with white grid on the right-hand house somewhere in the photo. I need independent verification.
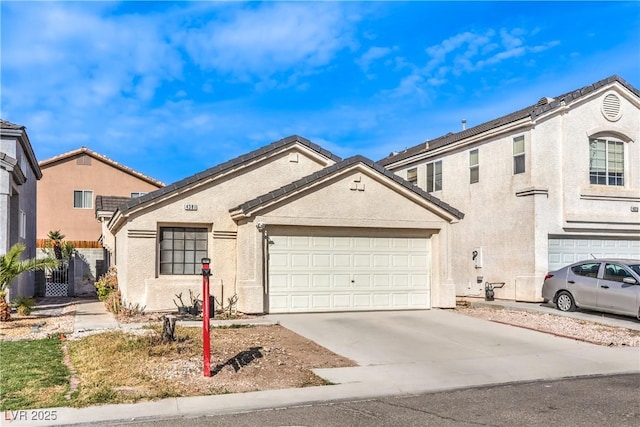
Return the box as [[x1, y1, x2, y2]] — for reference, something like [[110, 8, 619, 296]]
[[589, 138, 624, 185]]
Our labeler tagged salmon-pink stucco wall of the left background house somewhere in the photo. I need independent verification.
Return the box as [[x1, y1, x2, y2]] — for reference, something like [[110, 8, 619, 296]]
[[37, 154, 160, 241]]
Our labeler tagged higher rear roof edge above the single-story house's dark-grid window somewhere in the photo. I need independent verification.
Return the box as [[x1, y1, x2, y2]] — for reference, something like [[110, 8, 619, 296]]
[[119, 135, 342, 213]]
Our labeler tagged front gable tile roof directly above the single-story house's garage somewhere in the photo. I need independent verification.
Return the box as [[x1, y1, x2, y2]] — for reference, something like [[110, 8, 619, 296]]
[[230, 155, 464, 219]]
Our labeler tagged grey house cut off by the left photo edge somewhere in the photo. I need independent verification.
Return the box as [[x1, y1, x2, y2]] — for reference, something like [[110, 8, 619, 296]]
[[0, 119, 42, 299]]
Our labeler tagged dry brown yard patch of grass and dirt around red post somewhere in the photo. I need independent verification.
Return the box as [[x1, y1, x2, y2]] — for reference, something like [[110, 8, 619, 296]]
[[67, 326, 354, 406]]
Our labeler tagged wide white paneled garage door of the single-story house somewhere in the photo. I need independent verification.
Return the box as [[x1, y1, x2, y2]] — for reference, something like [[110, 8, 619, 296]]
[[268, 236, 431, 313]]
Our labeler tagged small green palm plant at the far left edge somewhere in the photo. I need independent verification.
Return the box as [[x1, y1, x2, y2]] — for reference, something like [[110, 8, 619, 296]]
[[0, 243, 59, 322]]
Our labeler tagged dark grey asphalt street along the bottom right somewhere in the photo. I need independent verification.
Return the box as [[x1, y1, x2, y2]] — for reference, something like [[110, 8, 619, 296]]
[[104, 374, 640, 427]]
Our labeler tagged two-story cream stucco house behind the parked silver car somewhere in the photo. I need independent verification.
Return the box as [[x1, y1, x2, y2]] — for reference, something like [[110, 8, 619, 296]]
[[379, 76, 640, 301]]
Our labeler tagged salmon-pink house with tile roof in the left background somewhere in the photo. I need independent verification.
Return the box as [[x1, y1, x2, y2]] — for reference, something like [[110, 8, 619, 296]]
[[37, 147, 164, 290]]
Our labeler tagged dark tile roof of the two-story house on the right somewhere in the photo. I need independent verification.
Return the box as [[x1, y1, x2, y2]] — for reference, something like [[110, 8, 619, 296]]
[[378, 75, 640, 166]]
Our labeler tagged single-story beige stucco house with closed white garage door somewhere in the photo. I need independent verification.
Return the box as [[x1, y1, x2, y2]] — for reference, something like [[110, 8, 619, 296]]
[[103, 136, 463, 313]]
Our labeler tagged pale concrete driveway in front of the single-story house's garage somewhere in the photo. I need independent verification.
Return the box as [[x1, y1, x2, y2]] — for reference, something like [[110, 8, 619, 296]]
[[269, 309, 640, 394]]
